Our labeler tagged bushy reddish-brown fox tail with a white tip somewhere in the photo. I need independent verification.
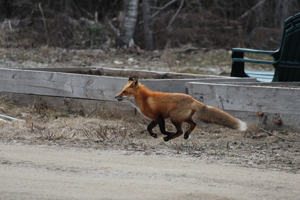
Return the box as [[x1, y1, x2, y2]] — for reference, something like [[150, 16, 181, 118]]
[[196, 102, 247, 131]]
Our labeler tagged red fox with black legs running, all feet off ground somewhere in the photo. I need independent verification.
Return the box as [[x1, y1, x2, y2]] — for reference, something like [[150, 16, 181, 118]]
[[115, 77, 247, 141]]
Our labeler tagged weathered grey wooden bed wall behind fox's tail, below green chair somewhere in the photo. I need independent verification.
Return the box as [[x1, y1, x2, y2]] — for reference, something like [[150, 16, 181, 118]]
[[187, 82, 300, 130]]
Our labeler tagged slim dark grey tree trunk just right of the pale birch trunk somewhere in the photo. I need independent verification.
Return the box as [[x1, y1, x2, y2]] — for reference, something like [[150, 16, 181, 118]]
[[142, 0, 153, 51]]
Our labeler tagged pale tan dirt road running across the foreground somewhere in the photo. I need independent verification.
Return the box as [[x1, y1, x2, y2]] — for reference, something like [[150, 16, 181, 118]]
[[0, 143, 300, 200]]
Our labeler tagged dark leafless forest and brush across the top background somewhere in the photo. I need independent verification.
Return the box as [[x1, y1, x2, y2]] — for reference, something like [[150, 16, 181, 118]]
[[0, 0, 300, 51]]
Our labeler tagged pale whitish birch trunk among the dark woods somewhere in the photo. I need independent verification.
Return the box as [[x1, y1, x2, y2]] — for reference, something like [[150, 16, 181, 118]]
[[118, 0, 139, 47]]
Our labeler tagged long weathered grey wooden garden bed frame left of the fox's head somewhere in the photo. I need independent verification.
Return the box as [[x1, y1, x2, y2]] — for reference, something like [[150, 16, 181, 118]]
[[0, 68, 256, 118]]
